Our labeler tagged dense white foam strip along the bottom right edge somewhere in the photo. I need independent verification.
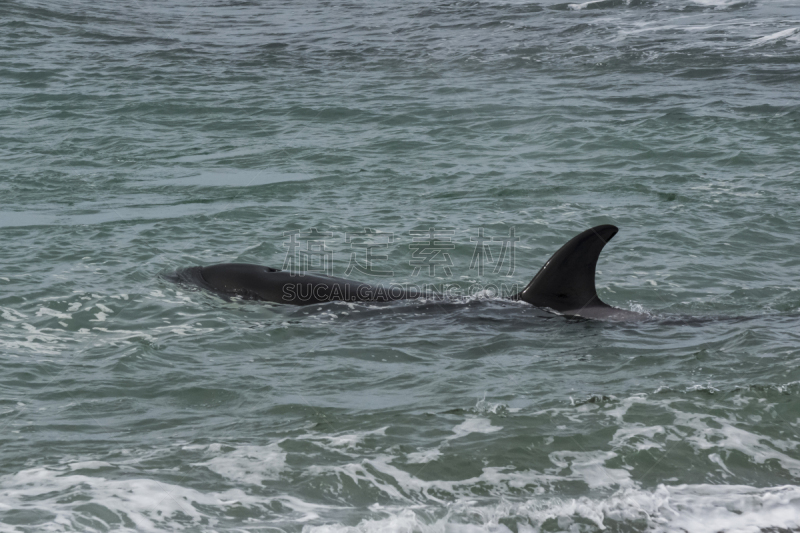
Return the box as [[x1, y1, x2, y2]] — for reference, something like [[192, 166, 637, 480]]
[[303, 485, 800, 533]]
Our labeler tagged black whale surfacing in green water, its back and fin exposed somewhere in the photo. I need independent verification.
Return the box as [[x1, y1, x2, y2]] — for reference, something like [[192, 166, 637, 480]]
[[173, 224, 647, 321]]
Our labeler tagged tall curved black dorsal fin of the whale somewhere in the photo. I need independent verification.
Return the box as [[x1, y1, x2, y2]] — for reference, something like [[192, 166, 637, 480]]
[[514, 224, 619, 314]]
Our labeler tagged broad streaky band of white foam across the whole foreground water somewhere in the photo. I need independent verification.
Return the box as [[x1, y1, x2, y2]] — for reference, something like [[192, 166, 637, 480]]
[[0, 386, 800, 533]]
